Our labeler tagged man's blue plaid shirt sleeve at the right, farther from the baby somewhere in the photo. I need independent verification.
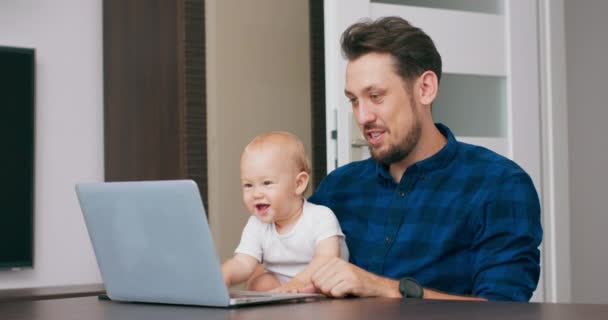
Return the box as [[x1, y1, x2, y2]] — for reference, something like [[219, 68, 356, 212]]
[[471, 173, 542, 301]]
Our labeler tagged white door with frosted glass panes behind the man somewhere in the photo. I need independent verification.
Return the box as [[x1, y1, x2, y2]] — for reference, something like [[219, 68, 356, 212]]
[[324, 0, 544, 301]]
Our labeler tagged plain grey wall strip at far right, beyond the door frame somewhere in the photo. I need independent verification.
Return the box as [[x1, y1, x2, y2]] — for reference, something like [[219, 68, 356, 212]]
[[564, 0, 608, 303]]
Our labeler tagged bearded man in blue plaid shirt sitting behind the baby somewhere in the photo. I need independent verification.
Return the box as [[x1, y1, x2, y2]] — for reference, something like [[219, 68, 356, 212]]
[[303, 17, 542, 301]]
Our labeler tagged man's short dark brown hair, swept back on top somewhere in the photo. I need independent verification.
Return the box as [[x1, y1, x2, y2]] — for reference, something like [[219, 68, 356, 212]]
[[341, 17, 441, 82]]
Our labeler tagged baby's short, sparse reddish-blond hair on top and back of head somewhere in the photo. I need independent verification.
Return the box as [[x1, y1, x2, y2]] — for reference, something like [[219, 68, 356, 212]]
[[243, 131, 312, 193]]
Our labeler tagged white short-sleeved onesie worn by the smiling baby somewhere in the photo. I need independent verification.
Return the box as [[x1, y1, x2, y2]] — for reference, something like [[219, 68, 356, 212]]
[[235, 201, 348, 283]]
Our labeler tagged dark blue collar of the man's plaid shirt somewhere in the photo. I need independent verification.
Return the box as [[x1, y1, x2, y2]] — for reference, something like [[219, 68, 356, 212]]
[[376, 123, 458, 181]]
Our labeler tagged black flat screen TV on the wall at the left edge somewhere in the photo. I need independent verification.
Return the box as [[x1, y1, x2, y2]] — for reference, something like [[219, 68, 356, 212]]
[[0, 46, 35, 269]]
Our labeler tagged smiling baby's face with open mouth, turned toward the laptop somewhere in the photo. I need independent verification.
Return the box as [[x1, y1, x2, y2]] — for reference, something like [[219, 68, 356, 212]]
[[241, 149, 302, 223]]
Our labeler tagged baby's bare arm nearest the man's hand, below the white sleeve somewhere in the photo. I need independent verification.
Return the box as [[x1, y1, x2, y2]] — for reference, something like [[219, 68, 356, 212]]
[[275, 236, 340, 293]]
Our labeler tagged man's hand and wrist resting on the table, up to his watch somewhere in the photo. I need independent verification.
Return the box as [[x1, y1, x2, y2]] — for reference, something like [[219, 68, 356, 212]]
[[299, 258, 401, 298]]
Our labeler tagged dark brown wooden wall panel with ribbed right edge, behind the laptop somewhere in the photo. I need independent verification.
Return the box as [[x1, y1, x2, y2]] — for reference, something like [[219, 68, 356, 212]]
[[103, 0, 207, 208]]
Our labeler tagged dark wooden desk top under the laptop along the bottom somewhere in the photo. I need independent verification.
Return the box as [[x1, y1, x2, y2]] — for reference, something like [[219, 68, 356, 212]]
[[0, 297, 608, 320]]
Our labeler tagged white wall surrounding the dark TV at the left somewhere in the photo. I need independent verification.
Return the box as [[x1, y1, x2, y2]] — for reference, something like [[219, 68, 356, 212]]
[[0, 0, 103, 289]]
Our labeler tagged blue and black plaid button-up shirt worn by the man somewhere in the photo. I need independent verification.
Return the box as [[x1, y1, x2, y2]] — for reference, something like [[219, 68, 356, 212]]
[[309, 124, 542, 301]]
